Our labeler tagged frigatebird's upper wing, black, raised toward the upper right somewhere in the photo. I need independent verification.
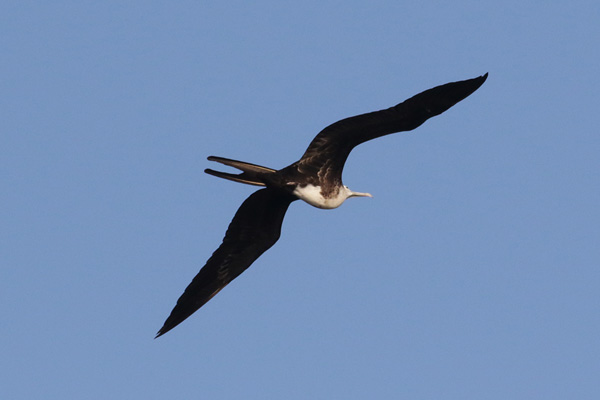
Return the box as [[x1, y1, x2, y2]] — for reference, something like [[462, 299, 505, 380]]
[[297, 73, 487, 178]]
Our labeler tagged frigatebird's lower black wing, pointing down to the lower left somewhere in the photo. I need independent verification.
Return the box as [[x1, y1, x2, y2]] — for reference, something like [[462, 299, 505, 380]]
[[156, 189, 296, 337]]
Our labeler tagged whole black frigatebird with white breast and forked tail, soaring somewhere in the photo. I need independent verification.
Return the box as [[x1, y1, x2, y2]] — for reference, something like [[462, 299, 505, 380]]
[[156, 73, 487, 337]]
